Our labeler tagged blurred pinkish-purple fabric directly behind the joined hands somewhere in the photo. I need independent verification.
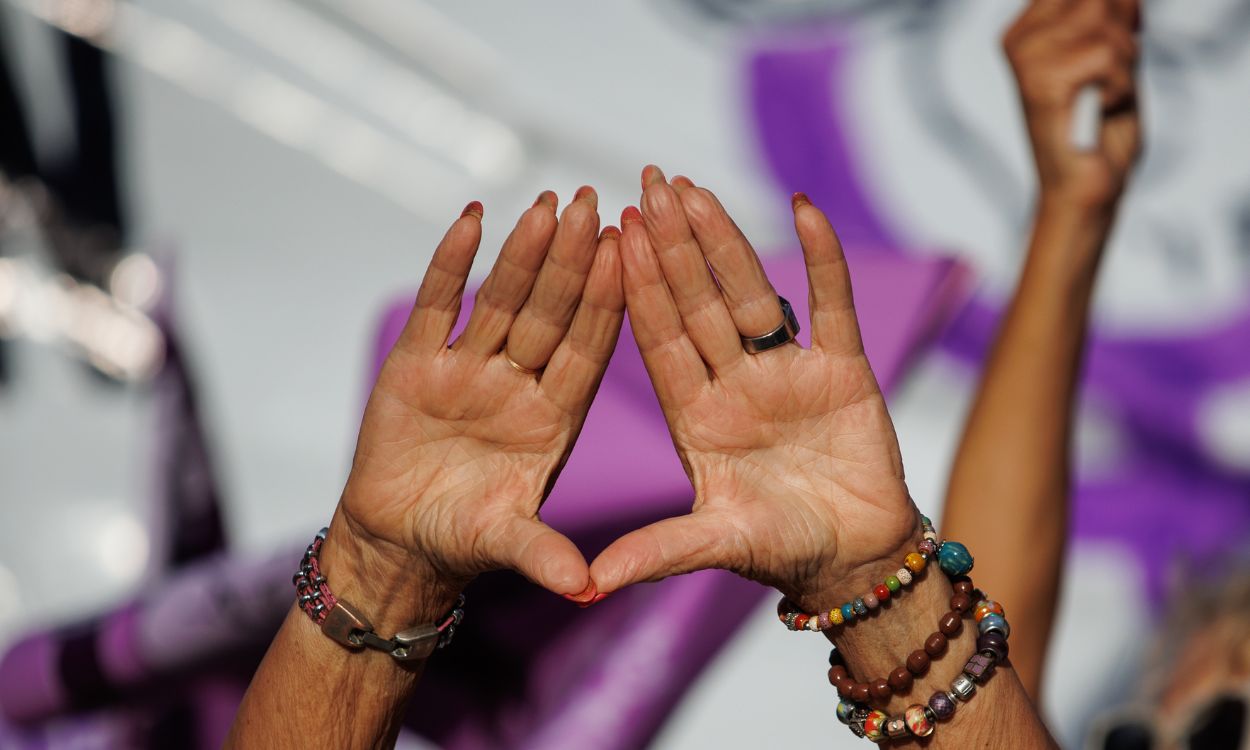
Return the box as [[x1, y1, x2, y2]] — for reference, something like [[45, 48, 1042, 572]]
[[375, 253, 965, 750]]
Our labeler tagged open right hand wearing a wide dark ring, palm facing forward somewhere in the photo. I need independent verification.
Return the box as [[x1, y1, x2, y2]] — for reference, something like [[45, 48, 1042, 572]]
[[591, 168, 918, 606]]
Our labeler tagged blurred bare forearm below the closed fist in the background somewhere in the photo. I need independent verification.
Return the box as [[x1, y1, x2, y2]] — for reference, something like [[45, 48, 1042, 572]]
[[940, 196, 1110, 695]]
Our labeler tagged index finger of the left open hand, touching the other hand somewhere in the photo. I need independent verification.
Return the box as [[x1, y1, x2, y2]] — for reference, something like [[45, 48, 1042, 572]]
[[541, 226, 625, 414]]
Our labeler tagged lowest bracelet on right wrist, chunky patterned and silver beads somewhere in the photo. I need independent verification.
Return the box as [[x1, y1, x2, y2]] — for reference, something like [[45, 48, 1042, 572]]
[[830, 591, 1011, 743]]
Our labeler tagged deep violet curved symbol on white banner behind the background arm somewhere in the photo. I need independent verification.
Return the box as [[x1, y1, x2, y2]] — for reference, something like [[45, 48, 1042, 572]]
[[748, 35, 1250, 604]]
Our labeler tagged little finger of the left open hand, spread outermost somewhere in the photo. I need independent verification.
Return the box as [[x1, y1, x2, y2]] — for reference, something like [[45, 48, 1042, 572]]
[[396, 201, 483, 351]]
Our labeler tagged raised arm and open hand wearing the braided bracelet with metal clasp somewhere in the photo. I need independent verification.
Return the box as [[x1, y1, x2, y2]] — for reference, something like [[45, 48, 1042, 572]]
[[228, 188, 625, 749]]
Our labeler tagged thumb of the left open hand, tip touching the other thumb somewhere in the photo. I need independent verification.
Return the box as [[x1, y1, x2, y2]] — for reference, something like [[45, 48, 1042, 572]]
[[485, 516, 591, 596]]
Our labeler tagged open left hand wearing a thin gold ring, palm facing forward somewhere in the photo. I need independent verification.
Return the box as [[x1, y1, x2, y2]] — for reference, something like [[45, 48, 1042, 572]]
[[343, 189, 624, 595]]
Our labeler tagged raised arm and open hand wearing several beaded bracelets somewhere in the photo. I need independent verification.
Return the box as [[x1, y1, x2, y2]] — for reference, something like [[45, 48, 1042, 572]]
[[591, 168, 1053, 749]]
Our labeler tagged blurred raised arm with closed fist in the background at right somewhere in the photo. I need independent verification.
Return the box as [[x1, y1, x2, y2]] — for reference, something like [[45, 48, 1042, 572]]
[[941, 0, 1140, 698]]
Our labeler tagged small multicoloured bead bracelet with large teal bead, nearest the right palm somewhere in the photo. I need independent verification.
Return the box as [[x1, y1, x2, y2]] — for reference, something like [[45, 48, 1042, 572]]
[[778, 515, 973, 633]]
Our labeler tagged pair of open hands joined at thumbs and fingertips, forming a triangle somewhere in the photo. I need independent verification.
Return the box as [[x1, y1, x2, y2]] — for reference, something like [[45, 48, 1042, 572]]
[[340, 172, 916, 612]]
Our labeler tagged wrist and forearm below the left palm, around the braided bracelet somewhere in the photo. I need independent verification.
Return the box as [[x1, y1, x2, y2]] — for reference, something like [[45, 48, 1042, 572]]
[[226, 513, 456, 748]]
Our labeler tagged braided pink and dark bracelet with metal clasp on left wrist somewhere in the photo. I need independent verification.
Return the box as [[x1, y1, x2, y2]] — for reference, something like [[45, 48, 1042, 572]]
[[291, 529, 465, 661]]
